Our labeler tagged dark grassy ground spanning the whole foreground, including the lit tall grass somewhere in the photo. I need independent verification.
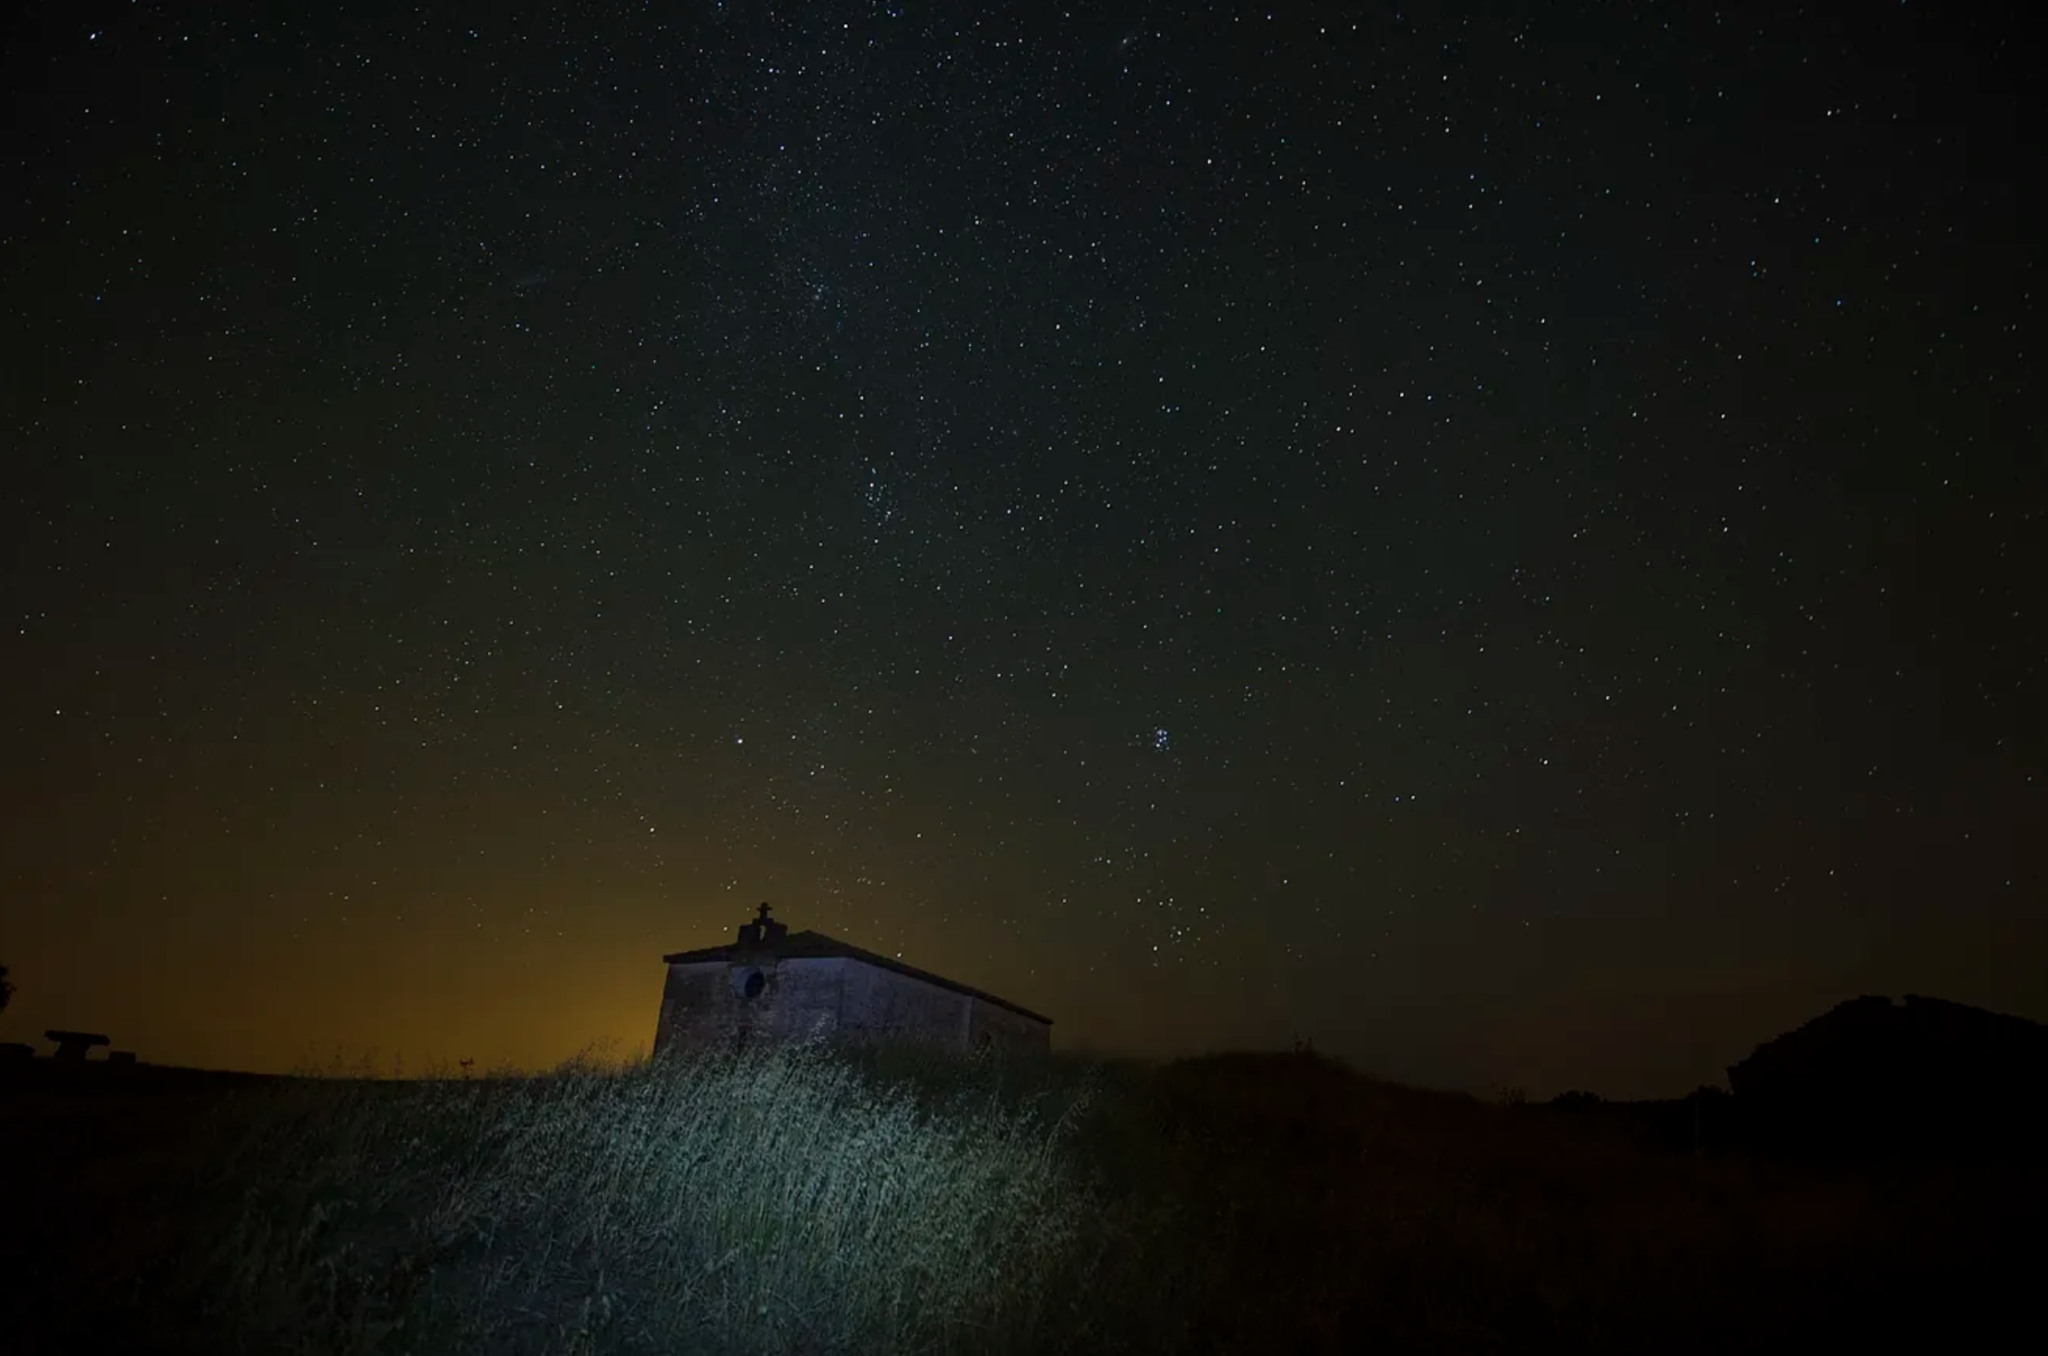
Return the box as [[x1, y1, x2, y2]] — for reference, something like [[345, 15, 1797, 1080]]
[[0, 1051, 2048, 1356]]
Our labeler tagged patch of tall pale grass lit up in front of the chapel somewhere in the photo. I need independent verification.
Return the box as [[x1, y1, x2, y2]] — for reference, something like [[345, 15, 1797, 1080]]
[[188, 1047, 1087, 1354]]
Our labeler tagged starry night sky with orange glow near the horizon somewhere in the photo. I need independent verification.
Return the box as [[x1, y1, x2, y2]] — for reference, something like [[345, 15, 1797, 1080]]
[[0, 0, 2048, 1096]]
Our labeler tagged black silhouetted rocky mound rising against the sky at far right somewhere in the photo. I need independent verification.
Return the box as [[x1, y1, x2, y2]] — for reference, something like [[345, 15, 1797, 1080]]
[[1729, 993, 2048, 1153]]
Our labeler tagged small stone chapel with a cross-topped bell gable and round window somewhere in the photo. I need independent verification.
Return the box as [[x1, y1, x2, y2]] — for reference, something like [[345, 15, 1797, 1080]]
[[653, 903, 1053, 1053]]
